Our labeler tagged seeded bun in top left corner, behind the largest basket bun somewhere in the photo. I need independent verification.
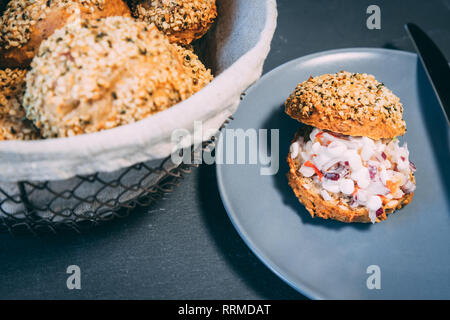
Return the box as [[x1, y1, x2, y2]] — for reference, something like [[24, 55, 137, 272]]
[[0, 0, 131, 68]]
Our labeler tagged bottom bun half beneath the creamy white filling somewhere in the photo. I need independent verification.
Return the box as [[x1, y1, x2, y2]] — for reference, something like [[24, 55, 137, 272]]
[[287, 128, 414, 223]]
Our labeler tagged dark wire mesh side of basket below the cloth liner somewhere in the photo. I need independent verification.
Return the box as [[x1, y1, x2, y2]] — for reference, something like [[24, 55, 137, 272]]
[[0, 120, 229, 233]]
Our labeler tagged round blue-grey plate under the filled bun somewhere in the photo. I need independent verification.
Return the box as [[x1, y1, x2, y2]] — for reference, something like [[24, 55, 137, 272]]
[[216, 48, 450, 299]]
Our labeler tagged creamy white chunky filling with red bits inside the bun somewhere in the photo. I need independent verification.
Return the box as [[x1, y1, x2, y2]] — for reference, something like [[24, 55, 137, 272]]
[[290, 128, 416, 222]]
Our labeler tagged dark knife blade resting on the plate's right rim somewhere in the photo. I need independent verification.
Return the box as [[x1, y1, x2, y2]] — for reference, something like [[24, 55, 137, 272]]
[[405, 23, 450, 124]]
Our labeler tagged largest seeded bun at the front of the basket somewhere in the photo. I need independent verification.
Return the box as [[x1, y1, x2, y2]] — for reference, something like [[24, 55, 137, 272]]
[[24, 17, 196, 138]]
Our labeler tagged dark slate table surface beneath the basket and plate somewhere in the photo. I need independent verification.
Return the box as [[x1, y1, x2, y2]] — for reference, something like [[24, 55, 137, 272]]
[[0, 0, 450, 299]]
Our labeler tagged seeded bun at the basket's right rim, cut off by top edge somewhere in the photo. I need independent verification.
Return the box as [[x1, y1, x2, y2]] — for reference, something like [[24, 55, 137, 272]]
[[131, 0, 217, 45]]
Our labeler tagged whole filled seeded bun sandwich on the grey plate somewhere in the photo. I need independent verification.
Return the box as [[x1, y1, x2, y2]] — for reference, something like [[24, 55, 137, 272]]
[[285, 71, 416, 223]]
